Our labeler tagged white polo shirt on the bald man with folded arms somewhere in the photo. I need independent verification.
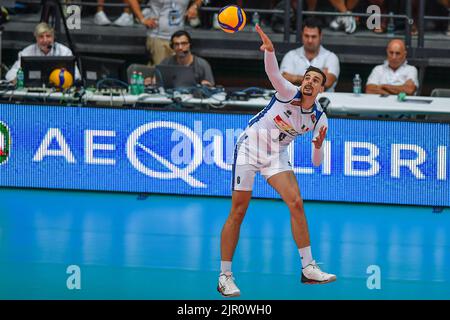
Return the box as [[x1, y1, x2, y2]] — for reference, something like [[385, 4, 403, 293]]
[[367, 60, 419, 87]]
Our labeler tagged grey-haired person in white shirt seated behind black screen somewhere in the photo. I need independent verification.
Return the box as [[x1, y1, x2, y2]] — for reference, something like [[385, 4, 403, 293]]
[[5, 22, 81, 83]]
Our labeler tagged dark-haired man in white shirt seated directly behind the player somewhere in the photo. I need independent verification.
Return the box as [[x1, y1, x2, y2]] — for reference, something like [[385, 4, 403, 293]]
[[280, 18, 340, 92]]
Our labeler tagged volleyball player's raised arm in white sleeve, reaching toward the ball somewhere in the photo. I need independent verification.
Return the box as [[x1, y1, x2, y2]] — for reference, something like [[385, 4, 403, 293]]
[[255, 25, 298, 101]]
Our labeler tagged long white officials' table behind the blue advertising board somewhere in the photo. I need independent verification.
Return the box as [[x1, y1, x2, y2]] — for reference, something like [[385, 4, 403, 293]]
[[1, 89, 450, 117]]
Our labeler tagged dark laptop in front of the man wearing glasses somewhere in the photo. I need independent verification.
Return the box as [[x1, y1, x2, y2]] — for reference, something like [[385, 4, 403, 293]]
[[155, 64, 197, 88]]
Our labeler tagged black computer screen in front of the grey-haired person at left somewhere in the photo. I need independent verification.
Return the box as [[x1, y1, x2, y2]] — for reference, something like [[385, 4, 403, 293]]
[[20, 56, 75, 87]]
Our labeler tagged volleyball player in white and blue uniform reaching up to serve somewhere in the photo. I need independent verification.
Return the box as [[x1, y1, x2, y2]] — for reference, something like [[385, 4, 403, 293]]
[[217, 25, 336, 297]]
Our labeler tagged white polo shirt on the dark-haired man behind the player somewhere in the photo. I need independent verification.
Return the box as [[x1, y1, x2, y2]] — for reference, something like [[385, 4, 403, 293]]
[[280, 46, 340, 92]]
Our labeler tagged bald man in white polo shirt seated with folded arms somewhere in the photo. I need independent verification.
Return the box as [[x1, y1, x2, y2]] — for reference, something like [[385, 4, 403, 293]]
[[366, 39, 419, 95]]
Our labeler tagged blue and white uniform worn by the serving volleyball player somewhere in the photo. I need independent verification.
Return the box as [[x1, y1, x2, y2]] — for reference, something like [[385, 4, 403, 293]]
[[232, 51, 328, 191]]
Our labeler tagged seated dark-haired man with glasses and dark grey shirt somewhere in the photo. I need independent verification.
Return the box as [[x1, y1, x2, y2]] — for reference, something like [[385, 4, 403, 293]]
[[160, 30, 214, 87]]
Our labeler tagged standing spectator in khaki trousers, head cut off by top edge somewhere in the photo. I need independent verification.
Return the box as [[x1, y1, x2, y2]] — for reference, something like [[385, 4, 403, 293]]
[[128, 0, 202, 66]]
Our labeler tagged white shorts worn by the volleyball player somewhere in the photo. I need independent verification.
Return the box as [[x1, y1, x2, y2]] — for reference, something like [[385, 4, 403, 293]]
[[232, 134, 293, 191]]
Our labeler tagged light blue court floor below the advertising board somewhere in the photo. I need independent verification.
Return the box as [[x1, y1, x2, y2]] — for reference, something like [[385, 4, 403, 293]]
[[0, 189, 450, 300]]
